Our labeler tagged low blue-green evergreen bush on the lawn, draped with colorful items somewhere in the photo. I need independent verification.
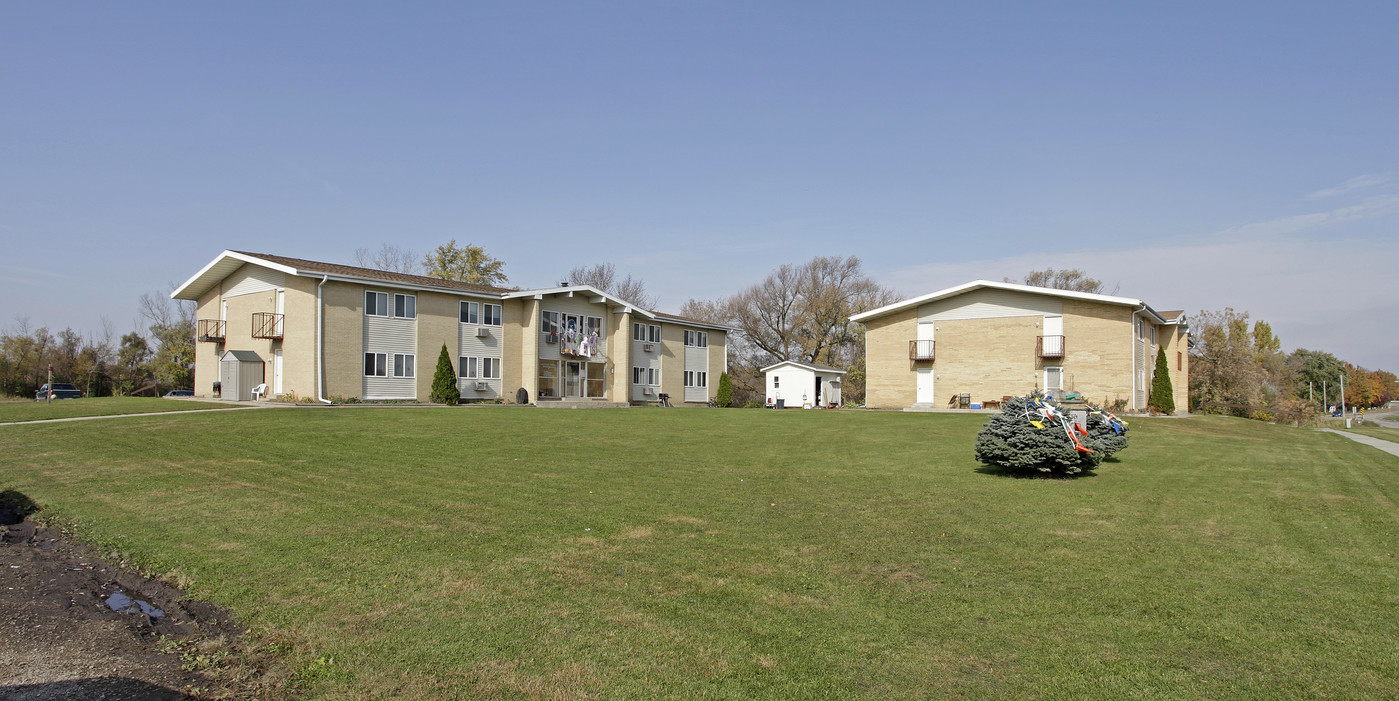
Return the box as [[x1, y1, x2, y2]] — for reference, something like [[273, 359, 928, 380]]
[[977, 390, 1128, 474]]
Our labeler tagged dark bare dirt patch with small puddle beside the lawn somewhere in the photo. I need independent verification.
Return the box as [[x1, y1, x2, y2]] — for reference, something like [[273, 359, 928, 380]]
[[0, 493, 278, 701]]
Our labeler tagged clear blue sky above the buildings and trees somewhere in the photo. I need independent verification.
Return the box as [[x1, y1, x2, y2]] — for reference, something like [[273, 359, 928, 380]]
[[0, 0, 1399, 371]]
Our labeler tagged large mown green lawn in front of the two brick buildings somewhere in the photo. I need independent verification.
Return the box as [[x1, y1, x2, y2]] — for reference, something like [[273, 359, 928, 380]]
[[0, 407, 1399, 700]]
